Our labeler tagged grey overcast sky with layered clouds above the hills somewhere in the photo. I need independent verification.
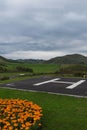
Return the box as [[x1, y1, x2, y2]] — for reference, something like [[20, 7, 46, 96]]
[[0, 0, 87, 59]]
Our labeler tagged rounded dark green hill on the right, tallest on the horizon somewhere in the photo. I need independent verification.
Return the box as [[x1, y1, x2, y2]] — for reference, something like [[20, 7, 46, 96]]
[[46, 54, 87, 64]]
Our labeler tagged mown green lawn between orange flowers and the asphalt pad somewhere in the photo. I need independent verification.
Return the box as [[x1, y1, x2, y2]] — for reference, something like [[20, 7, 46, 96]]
[[0, 88, 87, 130]]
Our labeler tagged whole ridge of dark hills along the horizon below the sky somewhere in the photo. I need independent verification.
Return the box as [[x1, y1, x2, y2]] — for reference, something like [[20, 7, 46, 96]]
[[0, 54, 87, 64]]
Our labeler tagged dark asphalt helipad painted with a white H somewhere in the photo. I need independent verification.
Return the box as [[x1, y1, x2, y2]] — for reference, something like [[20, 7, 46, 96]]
[[3, 76, 87, 96]]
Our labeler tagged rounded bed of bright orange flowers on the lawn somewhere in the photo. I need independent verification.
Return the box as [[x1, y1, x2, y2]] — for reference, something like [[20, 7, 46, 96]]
[[0, 99, 42, 130]]
